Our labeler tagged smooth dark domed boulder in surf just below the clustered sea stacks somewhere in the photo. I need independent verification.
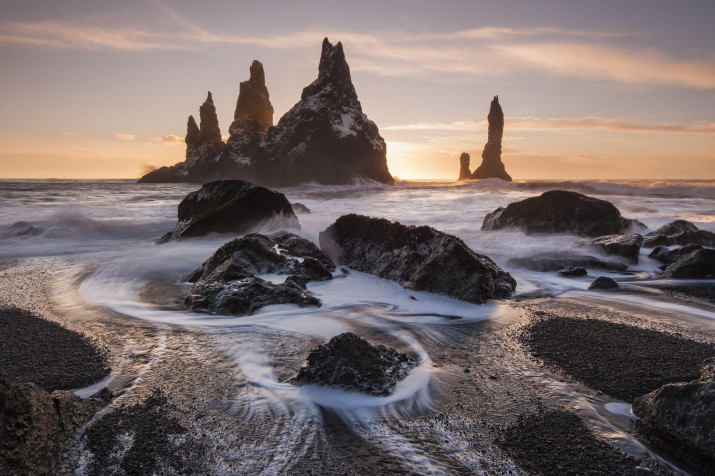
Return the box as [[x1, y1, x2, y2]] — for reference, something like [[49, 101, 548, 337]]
[[158, 180, 300, 243]]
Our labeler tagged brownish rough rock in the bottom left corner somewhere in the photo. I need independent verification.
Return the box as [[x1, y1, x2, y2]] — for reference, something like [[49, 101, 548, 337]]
[[0, 379, 103, 474]]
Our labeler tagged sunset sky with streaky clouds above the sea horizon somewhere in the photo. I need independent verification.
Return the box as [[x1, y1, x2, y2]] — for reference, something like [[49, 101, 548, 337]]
[[0, 0, 715, 179]]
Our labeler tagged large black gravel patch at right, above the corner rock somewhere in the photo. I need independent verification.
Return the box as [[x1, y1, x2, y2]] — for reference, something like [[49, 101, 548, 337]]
[[522, 313, 715, 402]]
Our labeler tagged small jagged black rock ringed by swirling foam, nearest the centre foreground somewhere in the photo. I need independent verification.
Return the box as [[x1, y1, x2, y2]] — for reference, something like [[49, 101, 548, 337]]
[[291, 332, 416, 396]]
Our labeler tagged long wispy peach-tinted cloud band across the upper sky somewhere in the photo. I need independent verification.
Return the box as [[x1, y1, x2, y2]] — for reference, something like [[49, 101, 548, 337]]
[[0, 1, 715, 89]]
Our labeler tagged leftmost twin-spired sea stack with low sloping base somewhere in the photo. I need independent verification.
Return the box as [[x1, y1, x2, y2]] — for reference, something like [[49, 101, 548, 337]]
[[139, 91, 224, 183]]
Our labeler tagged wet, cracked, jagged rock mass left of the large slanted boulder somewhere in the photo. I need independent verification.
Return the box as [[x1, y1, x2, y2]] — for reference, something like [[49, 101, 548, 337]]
[[185, 233, 335, 315]]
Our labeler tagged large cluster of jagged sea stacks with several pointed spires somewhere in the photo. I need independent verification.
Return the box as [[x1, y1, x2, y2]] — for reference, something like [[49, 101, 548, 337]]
[[139, 38, 393, 186]]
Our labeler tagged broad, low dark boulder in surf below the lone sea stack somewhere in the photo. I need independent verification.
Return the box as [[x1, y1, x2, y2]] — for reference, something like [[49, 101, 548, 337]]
[[482, 190, 633, 238]]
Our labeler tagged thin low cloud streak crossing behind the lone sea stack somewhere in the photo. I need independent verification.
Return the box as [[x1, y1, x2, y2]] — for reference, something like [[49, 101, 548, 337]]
[[380, 117, 715, 135]]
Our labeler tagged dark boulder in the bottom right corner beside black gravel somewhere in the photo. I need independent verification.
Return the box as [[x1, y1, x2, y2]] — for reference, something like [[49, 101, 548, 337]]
[[633, 360, 715, 470]]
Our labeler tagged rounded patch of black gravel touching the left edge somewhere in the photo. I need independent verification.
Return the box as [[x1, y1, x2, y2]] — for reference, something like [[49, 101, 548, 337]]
[[0, 308, 111, 392]]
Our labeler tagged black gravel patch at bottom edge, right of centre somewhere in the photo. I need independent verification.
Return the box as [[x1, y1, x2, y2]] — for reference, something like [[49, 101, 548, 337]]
[[496, 410, 652, 475]]
